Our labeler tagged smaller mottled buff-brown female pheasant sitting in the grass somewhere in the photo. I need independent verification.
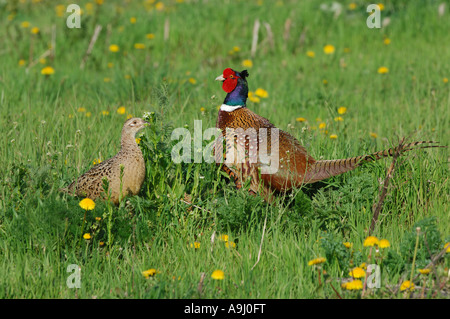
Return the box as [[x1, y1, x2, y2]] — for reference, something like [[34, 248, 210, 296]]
[[61, 118, 150, 205]]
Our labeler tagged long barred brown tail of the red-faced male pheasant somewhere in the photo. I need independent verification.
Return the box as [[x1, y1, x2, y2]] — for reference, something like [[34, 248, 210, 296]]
[[304, 141, 445, 183]]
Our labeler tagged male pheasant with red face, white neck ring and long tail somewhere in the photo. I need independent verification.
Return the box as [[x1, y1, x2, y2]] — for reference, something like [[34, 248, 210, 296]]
[[215, 68, 440, 201]]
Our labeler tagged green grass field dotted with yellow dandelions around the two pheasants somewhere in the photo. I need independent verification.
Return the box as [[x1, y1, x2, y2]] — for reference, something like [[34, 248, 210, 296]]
[[0, 0, 450, 298]]
